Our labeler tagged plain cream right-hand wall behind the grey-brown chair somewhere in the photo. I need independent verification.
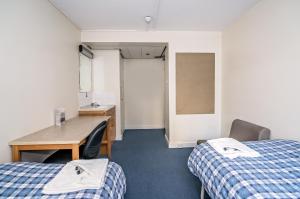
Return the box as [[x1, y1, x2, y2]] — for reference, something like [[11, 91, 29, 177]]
[[222, 0, 300, 140]]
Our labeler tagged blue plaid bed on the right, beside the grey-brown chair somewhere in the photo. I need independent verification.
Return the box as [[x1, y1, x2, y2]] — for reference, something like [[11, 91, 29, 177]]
[[188, 140, 300, 199]]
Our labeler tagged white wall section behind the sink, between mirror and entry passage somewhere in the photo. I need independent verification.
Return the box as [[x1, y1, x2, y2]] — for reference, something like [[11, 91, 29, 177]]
[[93, 50, 122, 140]]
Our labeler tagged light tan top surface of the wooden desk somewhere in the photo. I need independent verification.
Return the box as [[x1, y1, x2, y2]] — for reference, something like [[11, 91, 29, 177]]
[[9, 116, 110, 145]]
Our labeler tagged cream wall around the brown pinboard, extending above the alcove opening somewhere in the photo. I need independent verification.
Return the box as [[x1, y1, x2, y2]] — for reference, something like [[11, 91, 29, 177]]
[[81, 31, 221, 147]]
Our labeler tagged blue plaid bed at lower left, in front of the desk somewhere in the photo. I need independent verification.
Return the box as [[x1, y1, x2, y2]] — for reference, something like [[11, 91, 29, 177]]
[[0, 162, 126, 199]]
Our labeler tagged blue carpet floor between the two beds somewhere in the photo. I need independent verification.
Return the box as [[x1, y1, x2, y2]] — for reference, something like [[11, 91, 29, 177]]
[[112, 129, 201, 199]]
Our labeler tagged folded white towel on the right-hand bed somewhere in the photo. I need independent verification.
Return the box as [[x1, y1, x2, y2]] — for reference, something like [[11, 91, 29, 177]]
[[207, 138, 260, 159]]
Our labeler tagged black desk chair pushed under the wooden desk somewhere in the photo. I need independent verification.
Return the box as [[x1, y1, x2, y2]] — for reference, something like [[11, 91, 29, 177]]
[[44, 121, 107, 164]]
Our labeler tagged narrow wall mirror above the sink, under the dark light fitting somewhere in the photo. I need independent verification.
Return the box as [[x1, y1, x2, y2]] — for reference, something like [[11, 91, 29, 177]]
[[79, 53, 92, 92]]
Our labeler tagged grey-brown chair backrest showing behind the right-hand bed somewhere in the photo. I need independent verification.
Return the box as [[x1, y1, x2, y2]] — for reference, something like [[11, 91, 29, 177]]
[[229, 119, 271, 141]]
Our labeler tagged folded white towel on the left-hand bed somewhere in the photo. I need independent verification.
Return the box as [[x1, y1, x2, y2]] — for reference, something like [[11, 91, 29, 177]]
[[42, 159, 108, 194]]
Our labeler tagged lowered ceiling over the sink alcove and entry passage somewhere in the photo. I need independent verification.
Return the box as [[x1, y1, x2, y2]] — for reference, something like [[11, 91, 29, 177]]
[[85, 42, 167, 59]]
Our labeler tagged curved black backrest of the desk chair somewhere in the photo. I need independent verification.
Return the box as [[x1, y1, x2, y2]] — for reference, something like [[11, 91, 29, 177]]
[[82, 121, 107, 159]]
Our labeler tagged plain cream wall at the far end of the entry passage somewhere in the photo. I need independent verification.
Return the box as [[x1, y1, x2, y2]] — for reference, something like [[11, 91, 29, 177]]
[[124, 59, 164, 129]]
